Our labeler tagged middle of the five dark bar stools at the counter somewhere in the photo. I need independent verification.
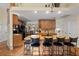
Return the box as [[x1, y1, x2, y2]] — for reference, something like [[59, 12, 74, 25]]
[[43, 38, 52, 56]]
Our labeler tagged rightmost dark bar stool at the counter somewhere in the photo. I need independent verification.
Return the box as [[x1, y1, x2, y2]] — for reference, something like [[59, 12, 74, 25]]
[[64, 37, 78, 55]]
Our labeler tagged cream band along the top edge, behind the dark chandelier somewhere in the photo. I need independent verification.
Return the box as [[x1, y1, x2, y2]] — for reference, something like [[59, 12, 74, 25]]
[[16, 3, 79, 7]]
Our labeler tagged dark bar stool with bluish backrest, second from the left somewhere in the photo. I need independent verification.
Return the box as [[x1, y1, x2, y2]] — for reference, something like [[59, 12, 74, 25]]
[[31, 38, 40, 55]]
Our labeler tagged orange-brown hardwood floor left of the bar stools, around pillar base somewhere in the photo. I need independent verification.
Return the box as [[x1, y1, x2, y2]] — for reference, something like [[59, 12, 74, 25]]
[[0, 42, 24, 56]]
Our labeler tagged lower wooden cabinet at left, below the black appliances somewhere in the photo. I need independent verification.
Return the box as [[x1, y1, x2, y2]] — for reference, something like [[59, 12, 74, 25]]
[[13, 34, 23, 47]]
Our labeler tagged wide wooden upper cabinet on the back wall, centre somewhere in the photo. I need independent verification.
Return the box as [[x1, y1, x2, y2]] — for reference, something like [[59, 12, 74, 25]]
[[39, 19, 56, 30]]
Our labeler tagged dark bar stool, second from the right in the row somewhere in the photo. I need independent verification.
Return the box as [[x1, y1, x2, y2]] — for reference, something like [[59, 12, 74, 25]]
[[53, 37, 65, 56]]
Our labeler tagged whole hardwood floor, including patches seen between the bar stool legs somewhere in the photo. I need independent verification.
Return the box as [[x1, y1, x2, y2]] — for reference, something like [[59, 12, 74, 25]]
[[0, 42, 79, 56]]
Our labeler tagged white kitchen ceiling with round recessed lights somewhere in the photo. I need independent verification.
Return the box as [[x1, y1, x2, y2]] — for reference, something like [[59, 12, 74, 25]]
[[13, 4, 79, 21]]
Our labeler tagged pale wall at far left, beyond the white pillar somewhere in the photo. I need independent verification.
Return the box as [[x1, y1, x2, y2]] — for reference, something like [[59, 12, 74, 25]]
[[0, 3, 8, 42]]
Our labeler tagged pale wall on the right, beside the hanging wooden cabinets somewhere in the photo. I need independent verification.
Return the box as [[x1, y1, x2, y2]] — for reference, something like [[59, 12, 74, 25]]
[[56, 15, 79, 47]]
